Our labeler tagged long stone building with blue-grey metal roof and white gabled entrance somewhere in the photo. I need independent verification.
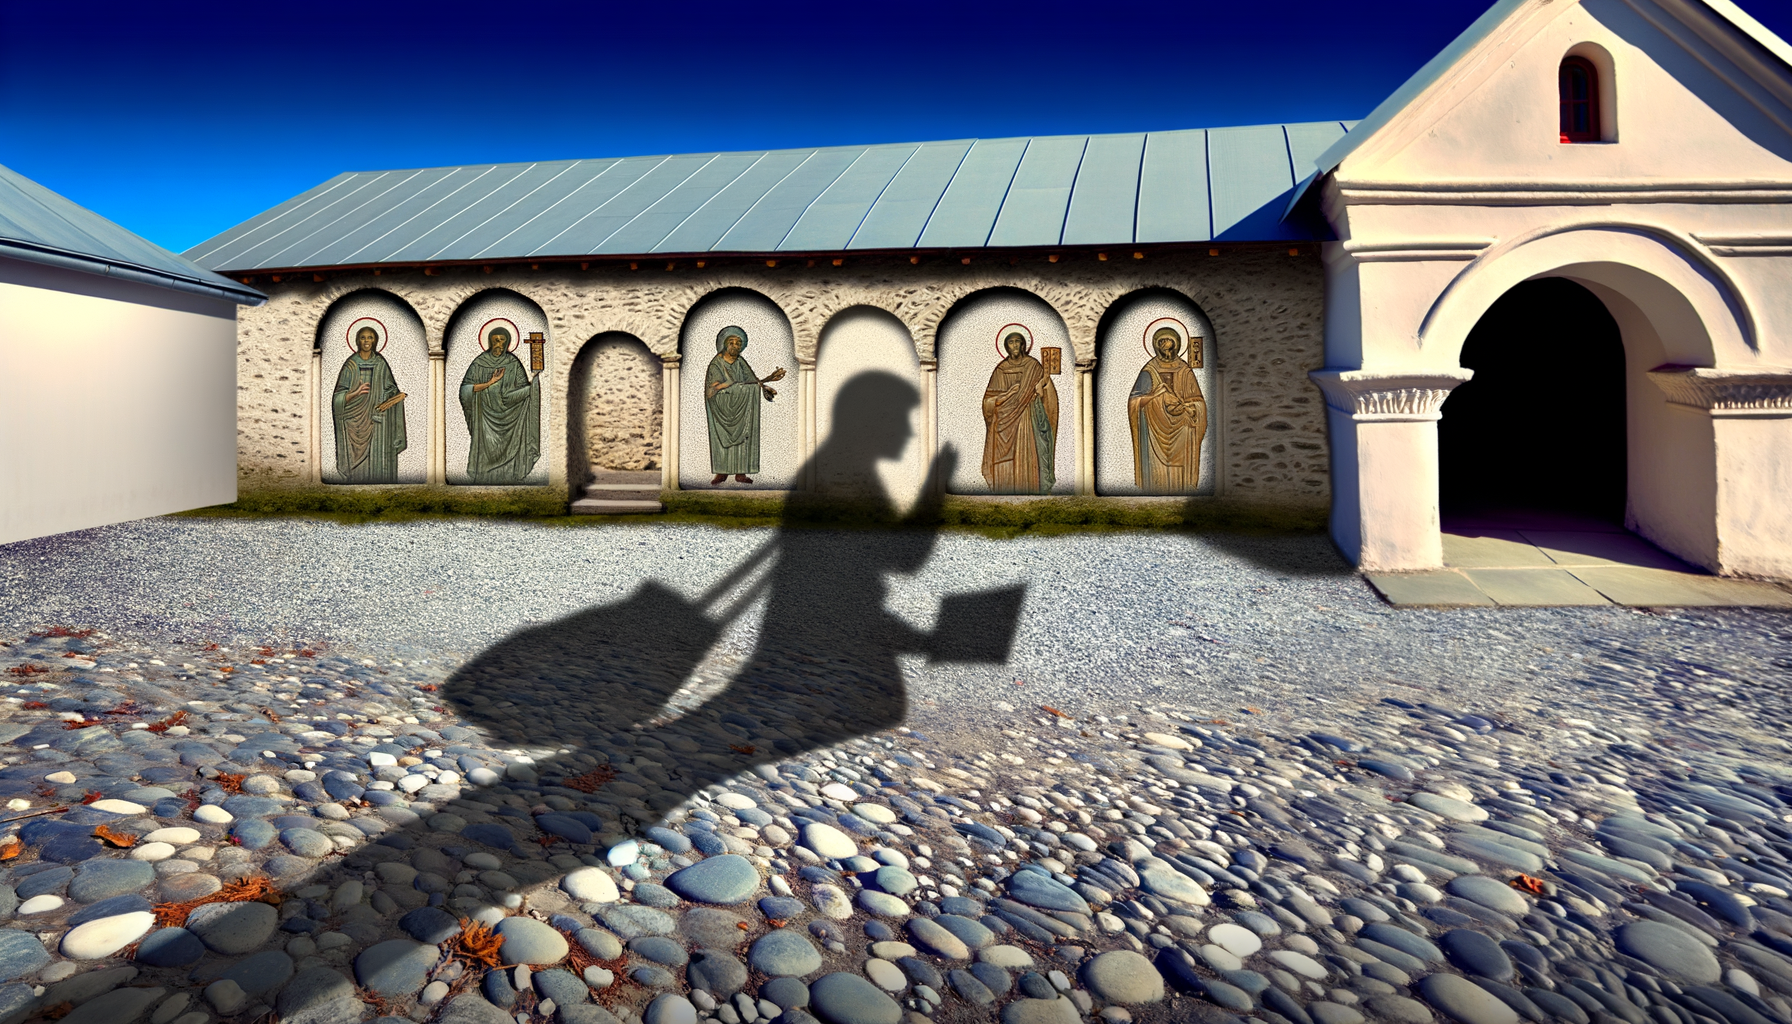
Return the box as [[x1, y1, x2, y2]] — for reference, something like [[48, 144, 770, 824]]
[[188, 0, 1792, 576]]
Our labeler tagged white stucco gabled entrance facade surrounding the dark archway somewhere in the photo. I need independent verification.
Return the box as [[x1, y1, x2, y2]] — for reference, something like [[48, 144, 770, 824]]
[[1322, 0, 1792, 576]]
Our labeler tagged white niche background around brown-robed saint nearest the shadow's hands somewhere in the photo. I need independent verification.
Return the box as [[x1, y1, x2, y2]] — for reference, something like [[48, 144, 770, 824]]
[[937, 291, 1075, 495]]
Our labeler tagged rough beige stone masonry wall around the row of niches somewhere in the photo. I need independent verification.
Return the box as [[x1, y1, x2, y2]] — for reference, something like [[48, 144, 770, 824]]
[[237, 249, 1330, 506]]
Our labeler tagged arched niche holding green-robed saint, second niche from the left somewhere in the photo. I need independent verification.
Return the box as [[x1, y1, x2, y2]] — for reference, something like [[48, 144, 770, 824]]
[[444, 291, 554, 486]]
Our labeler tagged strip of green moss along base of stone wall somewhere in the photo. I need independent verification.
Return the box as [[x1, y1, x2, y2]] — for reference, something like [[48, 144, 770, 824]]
[[192, 488, 1326, 536]]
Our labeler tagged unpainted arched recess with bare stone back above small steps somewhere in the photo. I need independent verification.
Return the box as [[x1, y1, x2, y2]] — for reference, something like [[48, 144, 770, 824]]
[[566, 332, 665, 484]]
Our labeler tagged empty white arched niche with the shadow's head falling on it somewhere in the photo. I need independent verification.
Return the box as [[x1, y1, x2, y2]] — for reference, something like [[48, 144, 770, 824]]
[[815, 307, 928, 509]]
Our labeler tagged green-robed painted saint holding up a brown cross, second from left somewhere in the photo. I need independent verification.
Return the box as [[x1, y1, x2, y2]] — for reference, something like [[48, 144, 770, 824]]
[[461, 326, 541, 484]]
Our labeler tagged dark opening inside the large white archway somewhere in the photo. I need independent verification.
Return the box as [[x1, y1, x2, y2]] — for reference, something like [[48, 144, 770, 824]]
[[1437, 278, 1627, 522]]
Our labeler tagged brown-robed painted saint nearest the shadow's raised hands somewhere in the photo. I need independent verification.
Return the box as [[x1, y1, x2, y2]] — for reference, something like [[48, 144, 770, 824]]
[[984, 325, 1057, 495]]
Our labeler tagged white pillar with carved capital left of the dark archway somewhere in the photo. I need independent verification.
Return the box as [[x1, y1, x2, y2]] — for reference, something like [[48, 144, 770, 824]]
[[1308, 368, 1473, 570]]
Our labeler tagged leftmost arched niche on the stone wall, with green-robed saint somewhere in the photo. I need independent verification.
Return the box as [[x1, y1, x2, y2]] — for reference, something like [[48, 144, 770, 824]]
[[314, 289, 430, 484]]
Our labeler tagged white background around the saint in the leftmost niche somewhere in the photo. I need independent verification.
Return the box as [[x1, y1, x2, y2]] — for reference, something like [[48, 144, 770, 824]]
[[317, 291, 426, 484]]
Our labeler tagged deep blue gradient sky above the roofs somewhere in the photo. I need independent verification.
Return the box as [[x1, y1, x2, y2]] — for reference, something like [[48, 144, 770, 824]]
[[10, 0, 1792, 251]]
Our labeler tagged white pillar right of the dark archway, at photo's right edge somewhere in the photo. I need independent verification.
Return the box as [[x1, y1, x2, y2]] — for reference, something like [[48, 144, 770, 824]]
[[1641, 366, 1792, 577]]
